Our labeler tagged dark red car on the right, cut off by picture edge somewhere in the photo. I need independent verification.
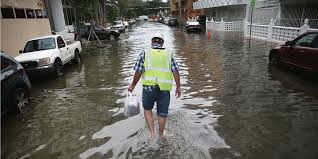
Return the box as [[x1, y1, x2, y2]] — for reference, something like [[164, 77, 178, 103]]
[[269, 32, 318, 74]]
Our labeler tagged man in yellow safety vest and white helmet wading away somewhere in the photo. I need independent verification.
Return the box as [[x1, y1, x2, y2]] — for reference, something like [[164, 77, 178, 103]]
[[128, 33, 181, 138]]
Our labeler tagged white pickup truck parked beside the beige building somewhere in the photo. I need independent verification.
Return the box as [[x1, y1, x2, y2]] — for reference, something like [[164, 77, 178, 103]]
[[15, 35, 82, 77]]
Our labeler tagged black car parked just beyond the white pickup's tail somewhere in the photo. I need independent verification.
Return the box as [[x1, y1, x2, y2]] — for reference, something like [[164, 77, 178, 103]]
[[79, 25, 120, 40]]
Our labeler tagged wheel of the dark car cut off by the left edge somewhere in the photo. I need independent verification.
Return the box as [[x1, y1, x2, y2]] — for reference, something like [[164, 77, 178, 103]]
[[13, 87, 30, 112]]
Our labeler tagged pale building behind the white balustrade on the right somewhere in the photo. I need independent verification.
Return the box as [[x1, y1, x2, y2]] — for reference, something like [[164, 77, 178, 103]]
[[193, 0, 318, 28]]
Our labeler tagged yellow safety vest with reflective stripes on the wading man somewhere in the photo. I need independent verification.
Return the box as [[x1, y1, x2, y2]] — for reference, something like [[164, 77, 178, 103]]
[[142, 49, 173, 91]]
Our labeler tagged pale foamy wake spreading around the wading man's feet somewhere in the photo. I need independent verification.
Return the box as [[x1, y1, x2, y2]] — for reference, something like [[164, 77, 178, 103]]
[[80, 105, 229, 159]]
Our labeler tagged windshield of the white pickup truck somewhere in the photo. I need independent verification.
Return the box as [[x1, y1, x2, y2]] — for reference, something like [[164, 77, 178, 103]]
[[23, 38, 56, 53]]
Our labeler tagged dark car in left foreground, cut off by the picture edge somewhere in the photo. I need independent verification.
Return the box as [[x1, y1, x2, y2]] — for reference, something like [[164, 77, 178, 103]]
[[1, 51, 31, 117]]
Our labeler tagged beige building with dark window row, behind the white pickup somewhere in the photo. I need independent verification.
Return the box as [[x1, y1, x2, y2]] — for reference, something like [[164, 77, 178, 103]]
[[0, 0, 51, 57]]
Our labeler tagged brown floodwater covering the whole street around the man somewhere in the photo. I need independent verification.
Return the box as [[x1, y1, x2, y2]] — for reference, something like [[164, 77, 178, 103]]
[[1, 23, 318, 159]]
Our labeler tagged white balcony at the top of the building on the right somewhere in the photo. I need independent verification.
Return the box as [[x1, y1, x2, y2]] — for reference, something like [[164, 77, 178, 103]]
[[193, 0, 249, 9]]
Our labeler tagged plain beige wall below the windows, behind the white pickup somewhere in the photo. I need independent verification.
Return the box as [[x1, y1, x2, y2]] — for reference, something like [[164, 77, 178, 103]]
[[0, 19, 51, 57]]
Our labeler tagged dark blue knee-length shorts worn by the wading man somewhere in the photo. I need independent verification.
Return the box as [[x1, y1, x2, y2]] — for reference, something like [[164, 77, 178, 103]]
[[142, 86, 170, 118]]
